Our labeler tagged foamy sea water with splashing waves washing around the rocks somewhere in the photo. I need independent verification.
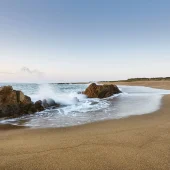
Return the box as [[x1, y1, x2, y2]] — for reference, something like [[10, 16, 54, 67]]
[[0, 84, 170, 128]]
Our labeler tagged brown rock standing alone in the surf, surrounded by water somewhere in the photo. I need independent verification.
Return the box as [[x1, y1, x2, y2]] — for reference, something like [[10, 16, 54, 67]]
[[83, 83, 121, 98]]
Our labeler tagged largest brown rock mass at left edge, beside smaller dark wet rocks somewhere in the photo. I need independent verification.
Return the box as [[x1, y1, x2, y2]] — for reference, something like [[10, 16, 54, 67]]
[[0, 86, 37, 117]]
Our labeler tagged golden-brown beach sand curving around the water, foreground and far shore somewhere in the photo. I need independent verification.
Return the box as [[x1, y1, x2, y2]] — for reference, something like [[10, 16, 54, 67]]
[[0, 82, 170, 170]]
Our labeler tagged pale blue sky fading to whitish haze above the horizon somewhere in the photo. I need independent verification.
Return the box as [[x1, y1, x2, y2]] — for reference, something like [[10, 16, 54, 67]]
[[0, 0, 170, 83]]
